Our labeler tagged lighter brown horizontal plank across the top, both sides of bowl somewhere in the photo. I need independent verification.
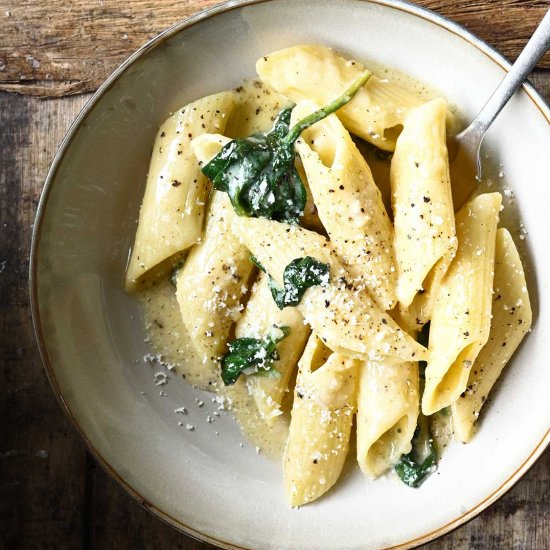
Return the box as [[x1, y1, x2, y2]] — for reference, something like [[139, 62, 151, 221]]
[[0, 0, 550, 97]]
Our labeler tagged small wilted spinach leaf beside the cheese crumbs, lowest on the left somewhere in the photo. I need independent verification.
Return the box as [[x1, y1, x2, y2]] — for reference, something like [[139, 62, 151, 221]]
[[221, 326, 290, 386]]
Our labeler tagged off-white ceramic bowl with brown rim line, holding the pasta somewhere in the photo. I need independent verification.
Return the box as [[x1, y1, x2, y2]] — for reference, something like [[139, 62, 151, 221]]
[[31, 0, 550, 549]]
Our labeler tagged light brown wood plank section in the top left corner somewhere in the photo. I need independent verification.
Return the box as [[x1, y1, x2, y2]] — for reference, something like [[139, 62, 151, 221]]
[[0, 0, 224, 97]]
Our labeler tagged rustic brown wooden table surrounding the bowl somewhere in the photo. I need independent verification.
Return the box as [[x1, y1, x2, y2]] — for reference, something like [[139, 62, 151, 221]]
[[0, 0, 550, 550]]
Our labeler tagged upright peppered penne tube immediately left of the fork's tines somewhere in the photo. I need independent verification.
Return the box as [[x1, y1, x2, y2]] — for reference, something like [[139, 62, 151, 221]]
[[390, 99, 457, 320]]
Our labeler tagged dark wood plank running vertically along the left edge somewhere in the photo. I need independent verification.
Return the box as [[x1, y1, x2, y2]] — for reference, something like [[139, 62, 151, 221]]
[[0, 93, 90, 549]]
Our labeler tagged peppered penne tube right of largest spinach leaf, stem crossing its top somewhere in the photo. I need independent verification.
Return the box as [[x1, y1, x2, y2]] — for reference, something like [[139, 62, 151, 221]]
[[292, 102, 397, 310]]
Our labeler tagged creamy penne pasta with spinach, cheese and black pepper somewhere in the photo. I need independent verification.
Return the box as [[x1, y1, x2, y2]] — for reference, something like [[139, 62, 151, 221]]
[[126, 45, 532, 506]]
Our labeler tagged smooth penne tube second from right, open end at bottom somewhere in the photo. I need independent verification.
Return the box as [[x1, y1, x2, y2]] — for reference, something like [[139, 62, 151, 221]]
[[422, 193, 502, 415]]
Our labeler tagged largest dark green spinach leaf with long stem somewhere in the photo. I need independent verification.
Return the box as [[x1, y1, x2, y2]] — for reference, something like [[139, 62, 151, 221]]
[[202, 71, 371, 223]]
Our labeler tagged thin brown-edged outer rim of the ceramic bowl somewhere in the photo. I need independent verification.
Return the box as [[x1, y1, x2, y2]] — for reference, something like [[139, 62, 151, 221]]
[[29, 0, 550, 550]]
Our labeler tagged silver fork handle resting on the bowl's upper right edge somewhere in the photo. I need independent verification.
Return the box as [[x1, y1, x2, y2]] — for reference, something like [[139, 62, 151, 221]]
[[462, 10, 550, 142]]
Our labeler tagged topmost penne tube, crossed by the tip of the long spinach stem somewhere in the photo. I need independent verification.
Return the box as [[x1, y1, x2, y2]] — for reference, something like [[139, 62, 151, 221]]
[[256, 45, 422, 151]]
